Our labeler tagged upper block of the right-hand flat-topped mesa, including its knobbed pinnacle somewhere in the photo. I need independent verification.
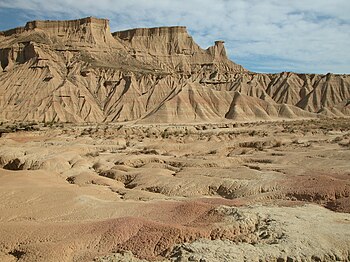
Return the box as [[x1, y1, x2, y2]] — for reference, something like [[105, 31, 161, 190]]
[[113, 26, 244, 72]]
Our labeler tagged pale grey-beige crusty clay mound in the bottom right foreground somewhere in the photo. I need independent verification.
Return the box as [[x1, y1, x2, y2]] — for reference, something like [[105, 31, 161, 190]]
[[171, 205, 350, 261]]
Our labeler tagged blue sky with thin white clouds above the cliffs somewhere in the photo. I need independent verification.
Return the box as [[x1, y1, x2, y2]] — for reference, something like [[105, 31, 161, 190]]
[[0, 0, 350, 74]]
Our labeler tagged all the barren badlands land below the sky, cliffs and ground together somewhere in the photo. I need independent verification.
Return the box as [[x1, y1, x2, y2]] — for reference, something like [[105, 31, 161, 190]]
[[0, 17, 350, 262]]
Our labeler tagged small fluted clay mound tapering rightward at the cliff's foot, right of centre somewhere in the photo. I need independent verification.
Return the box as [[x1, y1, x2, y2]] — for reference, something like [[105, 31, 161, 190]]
[[225, 92, 315, 121]]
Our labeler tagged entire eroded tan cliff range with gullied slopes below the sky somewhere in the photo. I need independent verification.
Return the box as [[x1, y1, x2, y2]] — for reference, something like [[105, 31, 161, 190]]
[[0, 18, 350, 122]]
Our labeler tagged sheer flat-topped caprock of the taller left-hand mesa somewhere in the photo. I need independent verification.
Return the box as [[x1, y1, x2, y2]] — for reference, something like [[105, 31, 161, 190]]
[[0, 17, 115, 44]]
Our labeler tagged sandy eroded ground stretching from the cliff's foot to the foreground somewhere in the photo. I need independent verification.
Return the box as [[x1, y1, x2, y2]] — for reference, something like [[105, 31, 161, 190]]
[[0, 119, 350, 261]]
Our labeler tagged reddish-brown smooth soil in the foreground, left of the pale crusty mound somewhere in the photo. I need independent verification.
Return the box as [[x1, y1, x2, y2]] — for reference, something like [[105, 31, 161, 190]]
[[0, 202, 227, 261]]
